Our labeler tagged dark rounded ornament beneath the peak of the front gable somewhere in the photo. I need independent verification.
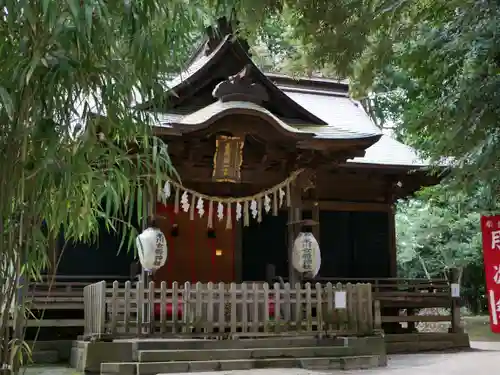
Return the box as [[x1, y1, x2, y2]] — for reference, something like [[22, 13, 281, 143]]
[[212, 64, 269, 104]]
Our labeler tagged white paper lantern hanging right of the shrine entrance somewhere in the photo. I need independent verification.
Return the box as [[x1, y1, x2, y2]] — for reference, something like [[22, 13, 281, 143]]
[[292, 232, 321, 277]]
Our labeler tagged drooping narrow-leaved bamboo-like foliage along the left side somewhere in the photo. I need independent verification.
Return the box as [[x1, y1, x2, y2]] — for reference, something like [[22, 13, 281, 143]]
[[0, 0, 213, 370]]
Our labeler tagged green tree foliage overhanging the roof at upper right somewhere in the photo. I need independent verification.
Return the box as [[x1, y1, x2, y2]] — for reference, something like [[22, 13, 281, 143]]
[[225, 0, 500, 194]]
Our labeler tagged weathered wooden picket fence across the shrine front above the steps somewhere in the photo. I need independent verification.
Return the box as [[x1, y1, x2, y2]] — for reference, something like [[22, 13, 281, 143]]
[[85, 281, 380, 338]]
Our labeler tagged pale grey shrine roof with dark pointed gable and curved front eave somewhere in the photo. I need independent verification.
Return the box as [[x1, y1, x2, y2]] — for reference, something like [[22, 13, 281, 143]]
[[138, 17, 427, 169]]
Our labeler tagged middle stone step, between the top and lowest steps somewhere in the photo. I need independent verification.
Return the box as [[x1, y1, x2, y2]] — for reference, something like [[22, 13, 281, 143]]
[[137, 346, 360, 362]]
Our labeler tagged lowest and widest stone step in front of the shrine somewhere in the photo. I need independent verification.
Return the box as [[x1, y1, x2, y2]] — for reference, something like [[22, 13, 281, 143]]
[[101, 355, 380, 375]]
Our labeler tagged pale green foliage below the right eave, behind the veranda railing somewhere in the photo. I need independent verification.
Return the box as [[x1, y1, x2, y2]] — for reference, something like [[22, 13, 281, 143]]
[[396, 185, 491, 312]]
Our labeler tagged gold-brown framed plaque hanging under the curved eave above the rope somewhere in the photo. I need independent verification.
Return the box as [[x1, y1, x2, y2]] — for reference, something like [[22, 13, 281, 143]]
[[212, 135, 245, 182]]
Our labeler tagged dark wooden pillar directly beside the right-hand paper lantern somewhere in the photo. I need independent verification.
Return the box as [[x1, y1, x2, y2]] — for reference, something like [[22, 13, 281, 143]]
[[288, 180, 302, 285]]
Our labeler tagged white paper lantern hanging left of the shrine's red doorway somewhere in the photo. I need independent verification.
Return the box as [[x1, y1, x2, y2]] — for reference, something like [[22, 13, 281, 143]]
[[135, 228, 167, 272]]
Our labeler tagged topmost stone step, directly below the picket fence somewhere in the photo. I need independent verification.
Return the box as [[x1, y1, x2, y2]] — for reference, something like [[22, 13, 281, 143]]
[[133, 337, 348, 351]]
